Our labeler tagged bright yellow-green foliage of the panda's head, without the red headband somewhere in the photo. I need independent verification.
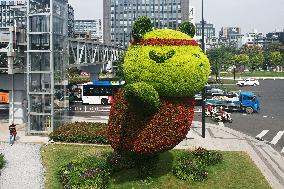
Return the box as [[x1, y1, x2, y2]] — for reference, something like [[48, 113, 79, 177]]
[[123, 30, 210, 97]]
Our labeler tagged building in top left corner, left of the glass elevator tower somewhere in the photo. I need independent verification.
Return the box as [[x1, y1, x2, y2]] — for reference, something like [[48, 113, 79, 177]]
[[0, 0, 27, 27]]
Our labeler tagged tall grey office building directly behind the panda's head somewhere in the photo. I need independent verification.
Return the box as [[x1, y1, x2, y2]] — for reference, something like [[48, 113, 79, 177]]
[[103, 0, 190, 46]]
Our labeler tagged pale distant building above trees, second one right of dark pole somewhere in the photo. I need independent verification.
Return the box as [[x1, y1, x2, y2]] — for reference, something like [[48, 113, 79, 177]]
[[219, 27, 244, 47]]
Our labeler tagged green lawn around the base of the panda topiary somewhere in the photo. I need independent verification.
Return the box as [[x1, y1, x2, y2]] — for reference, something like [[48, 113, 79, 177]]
[[41, 145, 271, 189]]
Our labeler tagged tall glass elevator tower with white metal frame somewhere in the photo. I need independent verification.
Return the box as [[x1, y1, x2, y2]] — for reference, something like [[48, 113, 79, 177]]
[[27, 0, 68, 134]]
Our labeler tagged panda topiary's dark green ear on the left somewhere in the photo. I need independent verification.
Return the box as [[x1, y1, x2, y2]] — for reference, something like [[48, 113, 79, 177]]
[[131, 16, 153, 41]]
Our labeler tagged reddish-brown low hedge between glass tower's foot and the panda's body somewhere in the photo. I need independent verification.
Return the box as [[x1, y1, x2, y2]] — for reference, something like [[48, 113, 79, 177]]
[[50, 122, 108, 144]]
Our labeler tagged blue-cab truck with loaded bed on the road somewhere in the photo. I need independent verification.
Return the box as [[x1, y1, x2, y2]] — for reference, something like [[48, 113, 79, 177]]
[[206, 92, 260, 114]]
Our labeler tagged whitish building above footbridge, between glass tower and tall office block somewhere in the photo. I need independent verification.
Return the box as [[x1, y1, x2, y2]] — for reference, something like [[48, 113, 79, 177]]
[[75, 19, 103, 42]]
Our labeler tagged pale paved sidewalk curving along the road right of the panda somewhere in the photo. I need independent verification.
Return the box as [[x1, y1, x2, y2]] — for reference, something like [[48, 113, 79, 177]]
[[176, 122, 284, 189]]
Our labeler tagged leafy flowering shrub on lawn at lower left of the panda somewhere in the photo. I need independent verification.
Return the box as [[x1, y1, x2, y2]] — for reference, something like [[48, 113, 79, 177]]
[[59, 155, 110, 189]]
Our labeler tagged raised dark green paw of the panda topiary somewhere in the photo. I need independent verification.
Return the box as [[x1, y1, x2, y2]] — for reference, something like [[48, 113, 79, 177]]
[[124, 82, 160, 115]]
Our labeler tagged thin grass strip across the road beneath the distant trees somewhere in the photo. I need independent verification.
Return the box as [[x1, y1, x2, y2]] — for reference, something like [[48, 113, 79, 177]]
[[220, 71, 284, 78]]
